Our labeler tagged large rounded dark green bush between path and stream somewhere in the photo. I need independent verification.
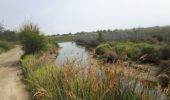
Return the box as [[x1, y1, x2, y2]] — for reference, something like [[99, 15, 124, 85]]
[[20, 23, 48, 54]]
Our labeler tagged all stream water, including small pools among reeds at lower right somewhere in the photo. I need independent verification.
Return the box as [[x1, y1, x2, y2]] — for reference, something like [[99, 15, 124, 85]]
[[55, 42, 167, 100]]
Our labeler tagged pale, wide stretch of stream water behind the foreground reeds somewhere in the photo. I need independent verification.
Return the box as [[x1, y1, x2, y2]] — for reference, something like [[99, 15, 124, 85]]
[[55, 42, 88, 66]]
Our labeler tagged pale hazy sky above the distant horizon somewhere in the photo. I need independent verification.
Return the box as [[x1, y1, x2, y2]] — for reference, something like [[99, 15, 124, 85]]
[[0, 0, 170, 35]]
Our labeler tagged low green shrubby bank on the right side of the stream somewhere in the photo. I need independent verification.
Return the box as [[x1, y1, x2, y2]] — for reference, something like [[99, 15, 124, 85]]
[[95, 42, 170, 63]]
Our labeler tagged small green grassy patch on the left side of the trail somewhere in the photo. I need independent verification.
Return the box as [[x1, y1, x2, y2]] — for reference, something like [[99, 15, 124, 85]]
[[0, 40, 14, 53]]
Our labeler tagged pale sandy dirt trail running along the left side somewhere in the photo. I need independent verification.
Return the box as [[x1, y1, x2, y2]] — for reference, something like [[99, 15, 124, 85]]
[[0, 46, 30, 100]]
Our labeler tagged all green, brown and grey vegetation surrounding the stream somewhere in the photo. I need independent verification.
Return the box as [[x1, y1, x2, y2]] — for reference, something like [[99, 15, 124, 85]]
[[0, 23, 167, 100]]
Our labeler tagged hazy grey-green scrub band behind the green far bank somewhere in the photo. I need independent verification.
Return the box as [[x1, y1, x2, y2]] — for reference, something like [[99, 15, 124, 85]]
[[74, 26, 170, 46]]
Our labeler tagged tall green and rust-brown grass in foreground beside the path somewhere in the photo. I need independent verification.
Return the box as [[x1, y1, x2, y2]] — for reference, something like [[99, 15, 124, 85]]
[[22, 52, 163, 100]]
